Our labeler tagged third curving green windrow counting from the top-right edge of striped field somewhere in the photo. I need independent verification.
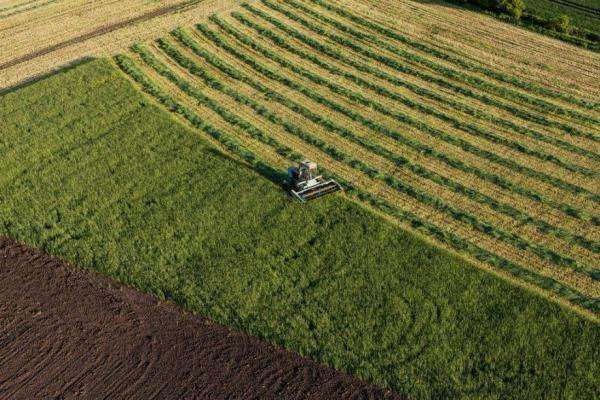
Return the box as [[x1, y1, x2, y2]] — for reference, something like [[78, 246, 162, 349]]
[[253, 0, 600, 142]]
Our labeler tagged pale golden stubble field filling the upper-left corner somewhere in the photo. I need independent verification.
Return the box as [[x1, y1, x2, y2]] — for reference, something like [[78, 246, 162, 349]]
[[0, 0, 244, 93]]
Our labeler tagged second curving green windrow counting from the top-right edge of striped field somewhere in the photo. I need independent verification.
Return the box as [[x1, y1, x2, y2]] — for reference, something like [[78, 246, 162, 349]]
[[278, 0, 600, 123]]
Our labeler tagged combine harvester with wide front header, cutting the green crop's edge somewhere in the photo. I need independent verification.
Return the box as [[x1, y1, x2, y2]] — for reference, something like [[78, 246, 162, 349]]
[[288, 160, 342, 202]]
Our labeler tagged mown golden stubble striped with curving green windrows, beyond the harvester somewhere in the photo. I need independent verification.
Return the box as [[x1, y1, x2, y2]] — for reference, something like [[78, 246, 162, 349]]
[[109, 0, 600, 314]]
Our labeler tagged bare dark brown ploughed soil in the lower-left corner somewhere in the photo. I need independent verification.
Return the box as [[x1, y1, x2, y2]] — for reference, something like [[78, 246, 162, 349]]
[[0, 237, 406, 399]]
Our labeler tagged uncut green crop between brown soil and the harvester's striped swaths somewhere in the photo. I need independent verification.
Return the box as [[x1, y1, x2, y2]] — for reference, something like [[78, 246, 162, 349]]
[[0, 59, 600, 399]]
